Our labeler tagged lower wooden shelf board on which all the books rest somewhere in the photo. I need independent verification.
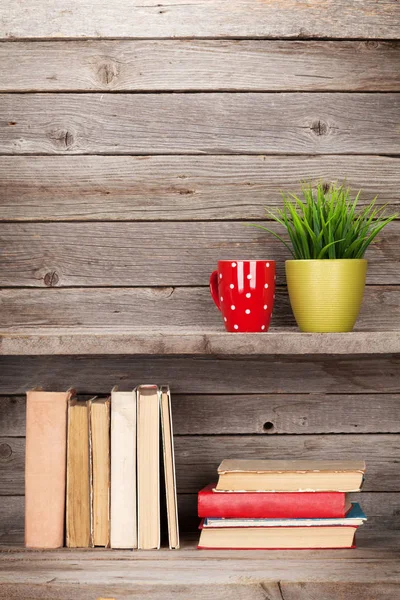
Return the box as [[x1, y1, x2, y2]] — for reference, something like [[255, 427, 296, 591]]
[[0, 526, 400, 600]]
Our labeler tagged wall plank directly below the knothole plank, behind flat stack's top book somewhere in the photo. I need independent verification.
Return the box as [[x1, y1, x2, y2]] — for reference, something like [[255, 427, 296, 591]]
[[0, 434, 400, 496]]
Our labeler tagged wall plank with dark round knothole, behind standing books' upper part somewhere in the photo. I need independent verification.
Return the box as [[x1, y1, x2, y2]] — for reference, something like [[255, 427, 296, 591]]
[[0, 390, 400, 437]]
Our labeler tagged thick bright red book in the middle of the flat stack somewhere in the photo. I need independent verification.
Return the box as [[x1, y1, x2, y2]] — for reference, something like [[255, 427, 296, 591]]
[[198, 483, 351, 519]]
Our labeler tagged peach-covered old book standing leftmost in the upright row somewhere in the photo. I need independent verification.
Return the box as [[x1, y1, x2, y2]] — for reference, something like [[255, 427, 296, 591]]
[[25, 390, 73, 548]]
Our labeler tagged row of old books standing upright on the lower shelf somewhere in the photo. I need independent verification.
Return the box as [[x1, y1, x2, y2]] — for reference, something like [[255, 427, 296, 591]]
[[25, 385, 179, 549]]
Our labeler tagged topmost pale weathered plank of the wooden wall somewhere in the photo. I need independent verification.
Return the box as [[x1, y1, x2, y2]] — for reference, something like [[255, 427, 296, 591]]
[[0, 0, 400, 39]]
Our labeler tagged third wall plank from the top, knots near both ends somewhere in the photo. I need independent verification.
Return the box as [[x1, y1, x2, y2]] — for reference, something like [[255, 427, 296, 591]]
[[0, 93, 400, 154]]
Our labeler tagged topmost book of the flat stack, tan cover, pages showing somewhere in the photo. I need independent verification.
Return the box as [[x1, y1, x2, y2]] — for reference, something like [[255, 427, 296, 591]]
[[215, 459, 365, 492]]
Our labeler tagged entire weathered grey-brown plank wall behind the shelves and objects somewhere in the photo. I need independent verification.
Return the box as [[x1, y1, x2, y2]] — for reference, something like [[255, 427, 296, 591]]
[[0, 0, 400, 544]]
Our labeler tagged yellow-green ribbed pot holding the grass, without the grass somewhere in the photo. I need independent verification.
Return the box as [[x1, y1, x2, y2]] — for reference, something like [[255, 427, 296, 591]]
[[285, 258, 367, 333]]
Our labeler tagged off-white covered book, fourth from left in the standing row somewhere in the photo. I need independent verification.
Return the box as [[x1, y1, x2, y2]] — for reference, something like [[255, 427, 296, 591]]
[[111, 388, 137, 548]]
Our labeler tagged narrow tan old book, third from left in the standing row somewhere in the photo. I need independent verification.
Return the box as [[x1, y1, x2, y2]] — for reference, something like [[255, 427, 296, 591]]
[[89, 398, 110, 547]]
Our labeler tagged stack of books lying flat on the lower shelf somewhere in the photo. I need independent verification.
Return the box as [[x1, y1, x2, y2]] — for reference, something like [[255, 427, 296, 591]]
[[198, 459, 366, 549]]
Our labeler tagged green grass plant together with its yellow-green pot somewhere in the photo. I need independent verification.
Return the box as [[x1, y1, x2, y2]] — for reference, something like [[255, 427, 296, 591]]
[[250, 183, 397, 333]]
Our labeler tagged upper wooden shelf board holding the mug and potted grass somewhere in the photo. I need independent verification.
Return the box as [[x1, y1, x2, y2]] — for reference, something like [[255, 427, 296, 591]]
[[0, 328, 400, 356]]
